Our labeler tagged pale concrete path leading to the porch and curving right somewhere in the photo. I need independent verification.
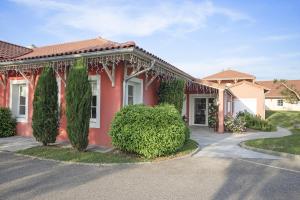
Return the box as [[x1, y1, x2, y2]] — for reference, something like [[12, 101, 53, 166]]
[[191, 127, 291, 159]]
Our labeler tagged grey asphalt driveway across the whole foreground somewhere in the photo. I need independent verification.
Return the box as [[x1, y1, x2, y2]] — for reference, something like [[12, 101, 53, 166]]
[[0, 152, 300, 200]]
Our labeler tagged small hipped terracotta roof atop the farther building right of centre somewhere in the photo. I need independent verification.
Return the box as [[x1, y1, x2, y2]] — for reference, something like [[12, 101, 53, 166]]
[[203, 70, 255, 80]]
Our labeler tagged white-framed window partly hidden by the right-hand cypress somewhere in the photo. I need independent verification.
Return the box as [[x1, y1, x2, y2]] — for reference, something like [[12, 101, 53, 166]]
[[89, 75, 100, 128]]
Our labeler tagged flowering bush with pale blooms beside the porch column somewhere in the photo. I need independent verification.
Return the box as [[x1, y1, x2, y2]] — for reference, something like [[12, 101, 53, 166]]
[[224, 115, 246, 133]]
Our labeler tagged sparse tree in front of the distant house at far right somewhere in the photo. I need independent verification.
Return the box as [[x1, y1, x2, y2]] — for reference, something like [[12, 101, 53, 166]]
[[273, 79, 300, 104]]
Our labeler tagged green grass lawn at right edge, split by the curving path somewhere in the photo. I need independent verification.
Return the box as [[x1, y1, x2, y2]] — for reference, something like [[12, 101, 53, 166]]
[[245, 111, 300, 155]]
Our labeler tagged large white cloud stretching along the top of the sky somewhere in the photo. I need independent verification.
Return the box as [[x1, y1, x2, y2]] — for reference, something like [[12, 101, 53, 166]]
[[12, 0, 253, 37]]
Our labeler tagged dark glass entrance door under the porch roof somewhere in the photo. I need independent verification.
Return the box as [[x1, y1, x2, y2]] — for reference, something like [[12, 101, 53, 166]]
[[194, 98, 207, 125]]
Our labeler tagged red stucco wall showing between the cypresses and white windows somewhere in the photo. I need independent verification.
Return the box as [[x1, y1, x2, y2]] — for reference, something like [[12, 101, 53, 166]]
[[0, 63, 159, 146]]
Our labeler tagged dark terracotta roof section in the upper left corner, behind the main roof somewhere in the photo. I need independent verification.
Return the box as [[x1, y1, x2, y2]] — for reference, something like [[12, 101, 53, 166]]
[[0, 40, 32, 61]]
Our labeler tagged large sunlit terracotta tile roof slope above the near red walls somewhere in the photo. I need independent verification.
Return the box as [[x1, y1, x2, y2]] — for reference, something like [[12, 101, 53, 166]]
[[0, 37, 135, 61]]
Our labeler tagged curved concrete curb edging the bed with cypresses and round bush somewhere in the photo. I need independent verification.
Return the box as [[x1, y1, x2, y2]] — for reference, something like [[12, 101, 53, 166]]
[[9, 140, 200, 167]]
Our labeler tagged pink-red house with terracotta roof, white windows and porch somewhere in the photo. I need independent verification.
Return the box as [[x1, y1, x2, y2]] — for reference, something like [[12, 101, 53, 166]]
[[0, 37, 266, 146]]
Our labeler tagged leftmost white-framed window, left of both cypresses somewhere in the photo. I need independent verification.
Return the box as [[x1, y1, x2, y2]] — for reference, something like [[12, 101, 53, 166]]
[[10, 80, 28, 122]]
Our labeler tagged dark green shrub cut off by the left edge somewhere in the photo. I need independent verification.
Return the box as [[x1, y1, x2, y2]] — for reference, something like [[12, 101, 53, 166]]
[[0, 108, 17, 137]]
